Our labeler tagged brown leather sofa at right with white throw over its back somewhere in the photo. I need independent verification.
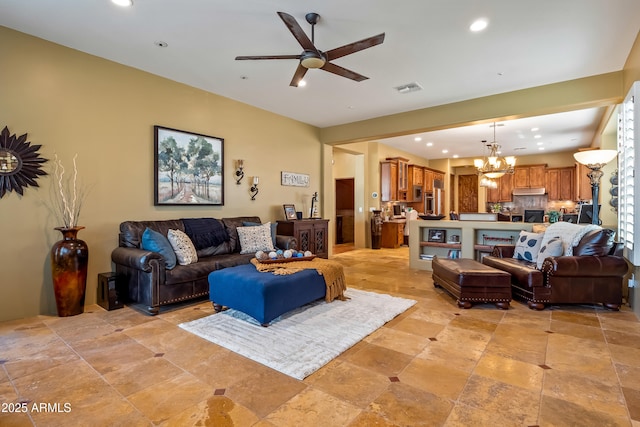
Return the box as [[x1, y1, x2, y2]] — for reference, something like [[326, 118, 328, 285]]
[[482, 229, 628, 310]]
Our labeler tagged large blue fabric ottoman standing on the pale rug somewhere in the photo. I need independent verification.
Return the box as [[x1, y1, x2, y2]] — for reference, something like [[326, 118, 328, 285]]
[[209, 264, 327, 326]]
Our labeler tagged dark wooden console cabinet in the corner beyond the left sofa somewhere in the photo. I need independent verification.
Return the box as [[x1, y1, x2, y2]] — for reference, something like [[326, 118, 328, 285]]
[[277, 219, 329, 258]]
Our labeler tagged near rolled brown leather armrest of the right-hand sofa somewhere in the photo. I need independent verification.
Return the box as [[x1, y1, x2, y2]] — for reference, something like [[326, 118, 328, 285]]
[[542, 256, 629, 277]]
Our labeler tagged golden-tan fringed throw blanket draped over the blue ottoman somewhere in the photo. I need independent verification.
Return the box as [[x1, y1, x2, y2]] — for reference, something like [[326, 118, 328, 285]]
[[251, 258, 347, 302]]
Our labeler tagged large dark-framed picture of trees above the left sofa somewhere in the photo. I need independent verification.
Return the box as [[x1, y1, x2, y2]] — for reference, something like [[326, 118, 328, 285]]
[[153, 125, 224, 206]]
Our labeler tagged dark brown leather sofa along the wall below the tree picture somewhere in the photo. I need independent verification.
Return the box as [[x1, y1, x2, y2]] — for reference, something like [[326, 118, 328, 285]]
[[111, 216, 297, 315]]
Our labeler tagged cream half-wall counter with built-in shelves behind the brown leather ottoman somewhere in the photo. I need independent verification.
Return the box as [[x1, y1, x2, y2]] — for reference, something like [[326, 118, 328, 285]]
[[406, 219, 535, 270]]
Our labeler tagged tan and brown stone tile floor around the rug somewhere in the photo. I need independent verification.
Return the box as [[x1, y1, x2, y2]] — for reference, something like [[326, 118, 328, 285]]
[[0, 248, 640, 427]]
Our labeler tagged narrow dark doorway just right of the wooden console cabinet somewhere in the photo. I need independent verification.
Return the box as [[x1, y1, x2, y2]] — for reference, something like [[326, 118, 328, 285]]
[[334, 178, 355, 253]]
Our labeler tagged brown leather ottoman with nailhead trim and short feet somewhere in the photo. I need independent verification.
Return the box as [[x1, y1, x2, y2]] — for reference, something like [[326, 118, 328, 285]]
[[431, 257, 511, 310]]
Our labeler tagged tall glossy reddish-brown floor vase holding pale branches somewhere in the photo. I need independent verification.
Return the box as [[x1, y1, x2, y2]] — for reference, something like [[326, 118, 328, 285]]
[[51, 227, 89, 317]]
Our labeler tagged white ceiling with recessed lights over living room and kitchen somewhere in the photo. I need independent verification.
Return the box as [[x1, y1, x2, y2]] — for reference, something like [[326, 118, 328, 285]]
[[0, 0, 640, 158]]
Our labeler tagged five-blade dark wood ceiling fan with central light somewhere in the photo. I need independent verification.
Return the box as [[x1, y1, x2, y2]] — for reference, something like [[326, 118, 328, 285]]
[[236, 12, 384, 87]]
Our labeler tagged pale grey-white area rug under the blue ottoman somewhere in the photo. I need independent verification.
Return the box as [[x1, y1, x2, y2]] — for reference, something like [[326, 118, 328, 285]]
[[180, 289, 416, 380]]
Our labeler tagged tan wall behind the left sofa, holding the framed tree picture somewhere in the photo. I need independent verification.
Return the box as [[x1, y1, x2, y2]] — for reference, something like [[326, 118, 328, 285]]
[[0, 27, 323, 321]]
